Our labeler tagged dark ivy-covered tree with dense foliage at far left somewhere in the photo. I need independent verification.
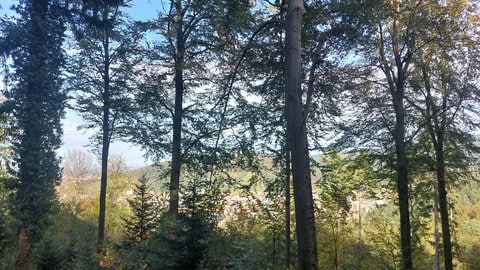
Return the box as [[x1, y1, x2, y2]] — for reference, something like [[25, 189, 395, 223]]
[[0, 0, 66, 269]]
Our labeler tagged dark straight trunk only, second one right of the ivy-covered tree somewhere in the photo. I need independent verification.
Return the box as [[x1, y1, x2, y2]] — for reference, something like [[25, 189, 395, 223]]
[[169, 0, 185, 221]]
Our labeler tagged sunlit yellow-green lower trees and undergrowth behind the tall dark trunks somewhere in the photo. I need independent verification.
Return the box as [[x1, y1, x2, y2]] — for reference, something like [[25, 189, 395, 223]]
[[2, 150, 480, 269]]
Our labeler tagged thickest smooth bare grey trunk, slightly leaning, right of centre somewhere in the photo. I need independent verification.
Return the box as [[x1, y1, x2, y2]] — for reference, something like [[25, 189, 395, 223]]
[[285, 0, 317, 270]]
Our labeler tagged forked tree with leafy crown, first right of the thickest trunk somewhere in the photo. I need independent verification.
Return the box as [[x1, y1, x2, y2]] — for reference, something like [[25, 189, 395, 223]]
[[334, 0, 431, 269]]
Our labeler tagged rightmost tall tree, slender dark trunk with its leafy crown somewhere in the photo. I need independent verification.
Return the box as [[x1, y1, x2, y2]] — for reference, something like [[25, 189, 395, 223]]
[[409, 2, 479, 270]]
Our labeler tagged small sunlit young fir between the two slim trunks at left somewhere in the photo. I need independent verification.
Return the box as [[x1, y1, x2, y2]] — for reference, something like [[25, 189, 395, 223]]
[[124, 175, 159, 245]]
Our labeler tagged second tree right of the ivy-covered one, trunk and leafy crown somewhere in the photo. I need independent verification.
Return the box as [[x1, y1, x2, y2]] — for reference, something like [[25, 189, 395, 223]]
[[125, 0, 256, 228]]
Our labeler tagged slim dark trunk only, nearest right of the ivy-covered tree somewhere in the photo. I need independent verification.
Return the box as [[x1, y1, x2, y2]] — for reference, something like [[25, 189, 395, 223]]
[[97, 7, 111, 255]]
